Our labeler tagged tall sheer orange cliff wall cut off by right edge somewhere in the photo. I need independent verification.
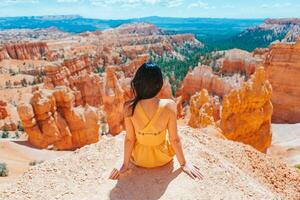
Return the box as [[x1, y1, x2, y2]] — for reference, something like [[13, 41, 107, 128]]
[[264, 40, 300, 123]]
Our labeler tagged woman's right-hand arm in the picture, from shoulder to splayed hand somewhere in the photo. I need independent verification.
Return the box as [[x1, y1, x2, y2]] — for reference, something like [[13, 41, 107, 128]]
[[168, 101, 203, 179]]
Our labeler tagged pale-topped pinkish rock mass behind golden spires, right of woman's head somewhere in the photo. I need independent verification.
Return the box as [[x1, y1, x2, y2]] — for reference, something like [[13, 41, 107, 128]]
[[181, 65, 244, 101]]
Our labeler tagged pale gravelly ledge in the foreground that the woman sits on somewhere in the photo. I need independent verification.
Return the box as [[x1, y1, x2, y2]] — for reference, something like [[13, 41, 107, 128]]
[[0, 127, 300, 200]]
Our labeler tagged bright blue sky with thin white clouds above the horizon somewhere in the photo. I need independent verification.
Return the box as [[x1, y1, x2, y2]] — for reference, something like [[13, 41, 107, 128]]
[[0, 0, 300, 19]]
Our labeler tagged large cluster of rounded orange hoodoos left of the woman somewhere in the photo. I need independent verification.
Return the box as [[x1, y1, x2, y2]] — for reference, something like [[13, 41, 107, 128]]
[[18, 87, 100, 150]]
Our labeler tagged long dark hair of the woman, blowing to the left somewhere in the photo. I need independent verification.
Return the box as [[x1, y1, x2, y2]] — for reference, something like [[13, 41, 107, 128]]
[[126, 62, 164, 115]]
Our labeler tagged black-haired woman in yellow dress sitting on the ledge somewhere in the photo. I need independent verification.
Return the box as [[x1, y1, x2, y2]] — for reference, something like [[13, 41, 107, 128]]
[[109, 62, 202, 180]]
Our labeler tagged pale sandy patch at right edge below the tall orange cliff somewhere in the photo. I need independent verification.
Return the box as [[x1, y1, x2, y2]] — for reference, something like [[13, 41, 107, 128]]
[[268, 124, 300, 166]]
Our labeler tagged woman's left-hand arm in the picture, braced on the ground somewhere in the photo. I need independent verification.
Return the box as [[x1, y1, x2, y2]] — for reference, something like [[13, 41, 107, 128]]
[[109, 114, 136, 180]]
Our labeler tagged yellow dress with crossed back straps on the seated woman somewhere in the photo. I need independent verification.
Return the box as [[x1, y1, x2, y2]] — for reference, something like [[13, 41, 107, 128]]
[[131, 99, 174, 168]]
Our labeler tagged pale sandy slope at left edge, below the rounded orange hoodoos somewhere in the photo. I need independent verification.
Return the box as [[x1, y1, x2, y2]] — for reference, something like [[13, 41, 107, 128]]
[[0, 139, 69, 185]]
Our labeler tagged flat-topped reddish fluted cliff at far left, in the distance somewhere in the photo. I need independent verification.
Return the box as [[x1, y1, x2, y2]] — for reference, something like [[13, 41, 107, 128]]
[[0, 42, 57, 61]]
